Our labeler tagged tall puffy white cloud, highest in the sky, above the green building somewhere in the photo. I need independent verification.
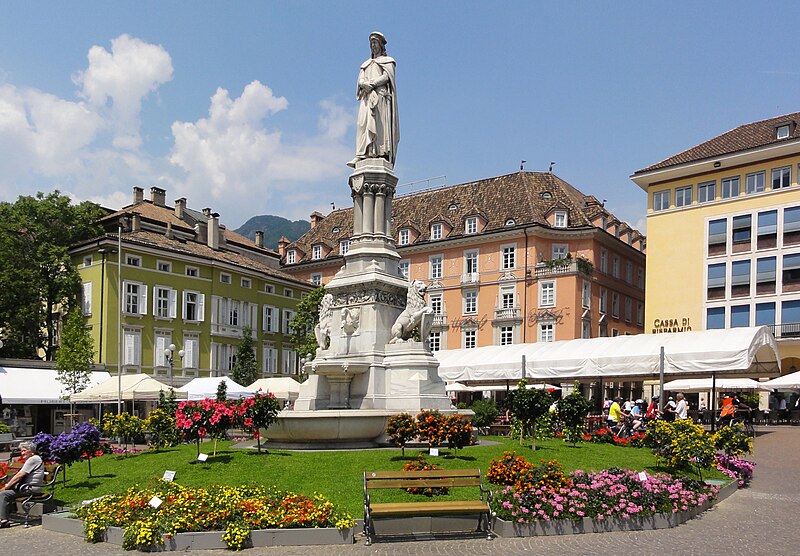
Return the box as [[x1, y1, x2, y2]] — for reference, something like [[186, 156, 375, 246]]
[[73, 35, 172, 149]]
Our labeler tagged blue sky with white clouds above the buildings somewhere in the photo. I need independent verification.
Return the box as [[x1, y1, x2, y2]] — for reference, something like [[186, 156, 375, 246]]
[[0, 0, 800, 231]]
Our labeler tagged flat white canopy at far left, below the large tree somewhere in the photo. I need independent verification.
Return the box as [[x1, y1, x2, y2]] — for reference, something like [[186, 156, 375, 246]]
[[0, 366, 111, 404]]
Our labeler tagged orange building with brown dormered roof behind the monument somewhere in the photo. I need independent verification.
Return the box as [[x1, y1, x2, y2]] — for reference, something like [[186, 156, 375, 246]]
[[278, 172, 645, 350]]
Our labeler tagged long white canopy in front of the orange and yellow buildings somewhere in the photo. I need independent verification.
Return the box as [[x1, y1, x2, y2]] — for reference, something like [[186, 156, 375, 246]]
[[435, 326, 780, 381]]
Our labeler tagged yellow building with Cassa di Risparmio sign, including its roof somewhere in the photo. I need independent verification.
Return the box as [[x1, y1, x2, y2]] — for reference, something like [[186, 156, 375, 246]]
[[631, 113, 800, 372]]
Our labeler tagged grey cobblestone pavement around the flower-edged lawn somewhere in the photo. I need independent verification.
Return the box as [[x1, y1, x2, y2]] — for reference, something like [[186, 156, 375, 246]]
[[0, 427, 800, 556]]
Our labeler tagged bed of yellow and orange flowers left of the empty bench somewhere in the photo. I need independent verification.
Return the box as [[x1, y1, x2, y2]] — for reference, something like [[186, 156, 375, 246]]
[[75, 480, 355, 549]]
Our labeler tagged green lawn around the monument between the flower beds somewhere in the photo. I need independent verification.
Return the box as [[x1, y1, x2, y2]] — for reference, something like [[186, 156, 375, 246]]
[[50, 437, 722, 517]]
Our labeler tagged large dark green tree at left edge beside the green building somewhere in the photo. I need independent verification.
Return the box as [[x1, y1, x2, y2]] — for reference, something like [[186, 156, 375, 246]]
[[0, 191, 104, 361]]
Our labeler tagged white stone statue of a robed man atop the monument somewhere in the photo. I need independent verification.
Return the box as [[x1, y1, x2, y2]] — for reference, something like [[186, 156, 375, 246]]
[[350, 32, 400, 166]]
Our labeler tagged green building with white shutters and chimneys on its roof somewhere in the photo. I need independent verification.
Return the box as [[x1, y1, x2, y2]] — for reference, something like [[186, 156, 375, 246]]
[[71, 187, 312, 386]]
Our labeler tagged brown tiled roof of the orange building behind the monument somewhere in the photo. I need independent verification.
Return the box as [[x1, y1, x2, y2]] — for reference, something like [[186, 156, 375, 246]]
[[288, 172, 640, 262]]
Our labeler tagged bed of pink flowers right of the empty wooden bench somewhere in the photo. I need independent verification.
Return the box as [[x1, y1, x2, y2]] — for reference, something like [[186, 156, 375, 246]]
[[491, 469, 718, 523]]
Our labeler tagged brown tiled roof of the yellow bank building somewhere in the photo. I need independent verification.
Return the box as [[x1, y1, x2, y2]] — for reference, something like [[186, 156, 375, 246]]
[[634, 112, 800, 175]]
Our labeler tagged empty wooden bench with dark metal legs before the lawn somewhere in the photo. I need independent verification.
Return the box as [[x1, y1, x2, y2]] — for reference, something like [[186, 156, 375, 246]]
[[364, 469, 492, 545]]
